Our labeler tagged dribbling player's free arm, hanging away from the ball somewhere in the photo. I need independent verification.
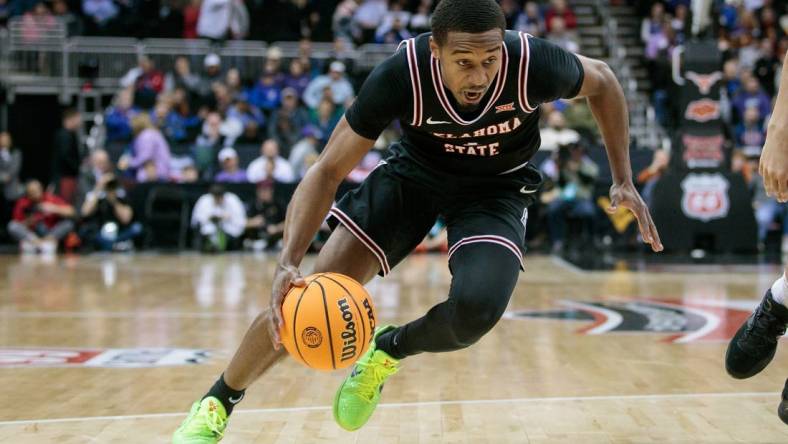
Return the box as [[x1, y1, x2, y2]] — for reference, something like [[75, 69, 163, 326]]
[[578, 55, 662, 251]]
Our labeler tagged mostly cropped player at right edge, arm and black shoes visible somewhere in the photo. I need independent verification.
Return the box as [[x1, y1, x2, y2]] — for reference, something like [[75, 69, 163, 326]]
[[725, 49, 788, 424]]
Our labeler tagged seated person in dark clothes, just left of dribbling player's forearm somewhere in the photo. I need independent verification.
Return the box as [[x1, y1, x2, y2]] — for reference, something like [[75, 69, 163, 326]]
[[244, 180, 287, 251]]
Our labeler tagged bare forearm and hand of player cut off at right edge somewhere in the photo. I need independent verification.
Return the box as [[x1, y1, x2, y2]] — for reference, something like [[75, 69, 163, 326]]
[[758, 53, 788, 202]]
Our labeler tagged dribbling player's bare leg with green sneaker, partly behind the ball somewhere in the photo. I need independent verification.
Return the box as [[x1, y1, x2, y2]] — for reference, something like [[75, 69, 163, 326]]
[[173, 227, 380, 444]]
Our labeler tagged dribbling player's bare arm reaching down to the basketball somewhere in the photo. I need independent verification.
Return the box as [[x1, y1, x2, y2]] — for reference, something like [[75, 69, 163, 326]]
[[270, 117, 375, 349]]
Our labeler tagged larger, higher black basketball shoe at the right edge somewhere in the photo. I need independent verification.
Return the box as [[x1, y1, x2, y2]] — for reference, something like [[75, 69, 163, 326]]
[[725, 290, 788, 379]]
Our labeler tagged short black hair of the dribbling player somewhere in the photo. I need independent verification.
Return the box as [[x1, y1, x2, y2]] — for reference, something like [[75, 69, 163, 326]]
[[432, 0, 506, 45]]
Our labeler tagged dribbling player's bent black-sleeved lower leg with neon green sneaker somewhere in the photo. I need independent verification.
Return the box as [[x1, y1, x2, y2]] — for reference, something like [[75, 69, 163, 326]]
[[334, 242, 520, 430]]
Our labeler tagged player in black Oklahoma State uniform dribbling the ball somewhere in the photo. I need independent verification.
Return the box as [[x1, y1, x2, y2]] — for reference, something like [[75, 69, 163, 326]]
[[174, 0, 662, 443]]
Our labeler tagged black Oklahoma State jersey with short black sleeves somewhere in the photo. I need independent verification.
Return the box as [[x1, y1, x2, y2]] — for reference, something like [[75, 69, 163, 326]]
[[345, 31, 583, 175]]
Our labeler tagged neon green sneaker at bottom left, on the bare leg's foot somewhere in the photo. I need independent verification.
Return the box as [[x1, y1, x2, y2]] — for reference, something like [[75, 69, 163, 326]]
[[172, 396, 227, 444]]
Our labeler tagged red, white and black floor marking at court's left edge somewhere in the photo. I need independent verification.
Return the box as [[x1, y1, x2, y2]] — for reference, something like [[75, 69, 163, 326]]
[[0, 348, 210, 368]]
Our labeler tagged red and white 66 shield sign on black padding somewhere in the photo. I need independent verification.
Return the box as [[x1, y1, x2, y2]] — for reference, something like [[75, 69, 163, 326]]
[[681, 173, 730, 222]]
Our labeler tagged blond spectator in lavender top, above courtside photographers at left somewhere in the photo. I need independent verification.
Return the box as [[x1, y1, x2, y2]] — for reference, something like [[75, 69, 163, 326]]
[[118, 114, 170, 182]]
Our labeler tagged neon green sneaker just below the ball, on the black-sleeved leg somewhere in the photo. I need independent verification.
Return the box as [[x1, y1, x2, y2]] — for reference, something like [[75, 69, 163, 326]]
[[334, 325, 399, 431]]
